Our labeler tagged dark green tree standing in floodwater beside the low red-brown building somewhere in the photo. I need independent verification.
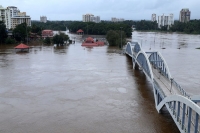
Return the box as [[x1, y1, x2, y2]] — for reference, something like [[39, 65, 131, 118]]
[[53, 33, 69, 45]]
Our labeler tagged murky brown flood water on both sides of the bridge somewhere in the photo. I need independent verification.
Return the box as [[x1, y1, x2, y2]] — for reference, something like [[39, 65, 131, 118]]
[[0, 32, 200, 133]]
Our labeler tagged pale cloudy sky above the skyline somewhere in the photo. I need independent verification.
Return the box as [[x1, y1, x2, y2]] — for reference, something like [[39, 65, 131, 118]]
[[0, 0, 200, 20]]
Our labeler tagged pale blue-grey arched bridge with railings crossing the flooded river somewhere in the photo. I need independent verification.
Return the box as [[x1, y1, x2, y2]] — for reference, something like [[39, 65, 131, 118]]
[[125, 42, 200, 133]]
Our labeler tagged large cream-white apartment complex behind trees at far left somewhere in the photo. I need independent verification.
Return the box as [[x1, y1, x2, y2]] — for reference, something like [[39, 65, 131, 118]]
[[0, 6, 31, 29]]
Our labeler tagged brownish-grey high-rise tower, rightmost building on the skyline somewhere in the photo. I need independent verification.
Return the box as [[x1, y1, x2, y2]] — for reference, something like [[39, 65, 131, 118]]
[[179, 8, 191, 23]]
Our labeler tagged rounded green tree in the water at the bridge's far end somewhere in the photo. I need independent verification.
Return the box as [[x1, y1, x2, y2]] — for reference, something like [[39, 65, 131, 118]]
[[106, 30, 126, 48]]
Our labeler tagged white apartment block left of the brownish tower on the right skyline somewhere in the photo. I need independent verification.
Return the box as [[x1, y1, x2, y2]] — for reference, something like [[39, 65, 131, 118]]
[[157, 13, 174, 28]]
